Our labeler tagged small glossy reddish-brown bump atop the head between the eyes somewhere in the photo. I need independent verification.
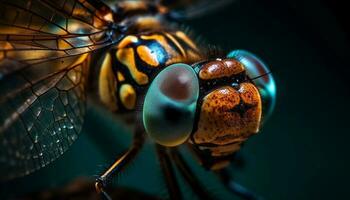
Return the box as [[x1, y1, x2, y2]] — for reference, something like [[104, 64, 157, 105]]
[[199, 59, 244, 80]]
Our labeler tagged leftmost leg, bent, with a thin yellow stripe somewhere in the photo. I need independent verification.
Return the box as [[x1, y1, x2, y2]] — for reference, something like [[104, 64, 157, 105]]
[[95, 125, 145, 200]]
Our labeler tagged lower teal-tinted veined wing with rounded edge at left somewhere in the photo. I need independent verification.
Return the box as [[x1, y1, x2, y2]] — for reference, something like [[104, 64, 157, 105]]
[[0, 54, 89, 179]]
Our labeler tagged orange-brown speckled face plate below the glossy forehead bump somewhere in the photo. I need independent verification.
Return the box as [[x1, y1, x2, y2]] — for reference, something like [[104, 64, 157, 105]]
[[193, 82, 261, 150]]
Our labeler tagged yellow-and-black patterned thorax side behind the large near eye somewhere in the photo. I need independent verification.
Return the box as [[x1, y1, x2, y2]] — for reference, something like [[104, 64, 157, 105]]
[[99, 31, 202, 110]]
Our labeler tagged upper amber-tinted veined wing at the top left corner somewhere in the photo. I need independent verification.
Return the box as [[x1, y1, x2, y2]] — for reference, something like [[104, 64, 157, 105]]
[[0, 0, 117, 68]]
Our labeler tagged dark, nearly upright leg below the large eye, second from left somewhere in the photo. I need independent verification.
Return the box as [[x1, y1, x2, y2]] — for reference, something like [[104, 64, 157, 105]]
[[156, 145, 183, 200]]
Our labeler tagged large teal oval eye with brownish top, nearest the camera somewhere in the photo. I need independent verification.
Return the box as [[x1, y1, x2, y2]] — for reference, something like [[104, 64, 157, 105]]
[[143, 63, 199, 147]]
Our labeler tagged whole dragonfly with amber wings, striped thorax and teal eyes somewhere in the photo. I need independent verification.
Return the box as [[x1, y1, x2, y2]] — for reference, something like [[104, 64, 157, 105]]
[[0, 0, 276, 199]]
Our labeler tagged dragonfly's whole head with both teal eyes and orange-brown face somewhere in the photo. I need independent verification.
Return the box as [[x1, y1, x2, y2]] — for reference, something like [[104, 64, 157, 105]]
[[143, 51, 274, 157]]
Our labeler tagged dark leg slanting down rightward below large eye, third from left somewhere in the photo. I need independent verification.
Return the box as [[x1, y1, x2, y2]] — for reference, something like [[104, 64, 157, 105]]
[[170, 148, 213, 199]]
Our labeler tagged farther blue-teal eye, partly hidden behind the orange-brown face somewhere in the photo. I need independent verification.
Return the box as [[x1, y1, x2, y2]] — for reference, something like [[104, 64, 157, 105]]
[[227, 50, 276, 122]]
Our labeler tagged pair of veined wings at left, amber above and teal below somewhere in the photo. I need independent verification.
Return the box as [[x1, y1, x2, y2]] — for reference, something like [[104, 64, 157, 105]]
[[0, 0, 117, 180]]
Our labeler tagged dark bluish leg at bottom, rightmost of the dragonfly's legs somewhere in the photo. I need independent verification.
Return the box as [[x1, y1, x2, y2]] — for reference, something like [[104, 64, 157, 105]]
[[217, 169, 262, 200]]
